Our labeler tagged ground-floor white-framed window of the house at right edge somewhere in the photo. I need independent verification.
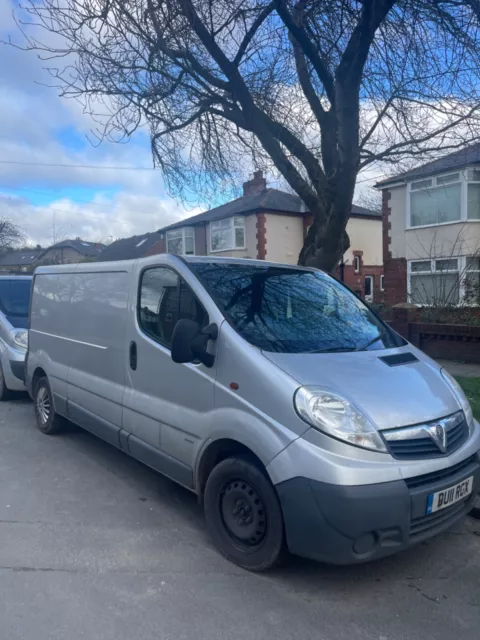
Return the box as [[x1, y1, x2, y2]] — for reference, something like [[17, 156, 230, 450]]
[[408, 258, 460, 306]]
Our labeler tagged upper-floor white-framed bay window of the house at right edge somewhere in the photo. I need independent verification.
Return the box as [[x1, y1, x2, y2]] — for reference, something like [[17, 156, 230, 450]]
[[407, 169, 480, 228]]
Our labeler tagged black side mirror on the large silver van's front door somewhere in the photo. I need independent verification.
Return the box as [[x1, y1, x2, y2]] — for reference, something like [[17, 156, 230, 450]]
[[171, 320, 218, 368]]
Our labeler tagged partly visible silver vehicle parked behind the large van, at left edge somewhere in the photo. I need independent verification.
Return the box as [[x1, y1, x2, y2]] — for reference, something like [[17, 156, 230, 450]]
[[0, 275, 32, 401]]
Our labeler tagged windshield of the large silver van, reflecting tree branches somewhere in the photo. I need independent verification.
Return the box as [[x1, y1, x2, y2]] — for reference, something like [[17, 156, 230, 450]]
[[192, 262, 406, 353]]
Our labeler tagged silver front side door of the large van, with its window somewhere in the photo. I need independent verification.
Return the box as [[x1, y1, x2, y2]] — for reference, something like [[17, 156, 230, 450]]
[[123, 266, 215, 486]]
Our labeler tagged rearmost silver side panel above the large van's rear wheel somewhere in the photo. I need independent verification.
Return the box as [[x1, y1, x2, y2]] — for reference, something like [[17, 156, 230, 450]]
[[27, 273, 74, 415]]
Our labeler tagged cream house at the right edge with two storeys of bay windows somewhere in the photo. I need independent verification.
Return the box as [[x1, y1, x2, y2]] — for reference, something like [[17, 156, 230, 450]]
[[375, 143, 480, 306]]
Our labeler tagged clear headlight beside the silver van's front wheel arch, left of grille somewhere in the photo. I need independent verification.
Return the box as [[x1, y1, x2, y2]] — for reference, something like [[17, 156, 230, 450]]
[[294, 387, 387, 453]]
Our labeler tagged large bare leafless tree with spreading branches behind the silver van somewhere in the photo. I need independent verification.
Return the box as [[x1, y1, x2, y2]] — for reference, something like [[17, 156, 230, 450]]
[[11, 0, 480, 270]]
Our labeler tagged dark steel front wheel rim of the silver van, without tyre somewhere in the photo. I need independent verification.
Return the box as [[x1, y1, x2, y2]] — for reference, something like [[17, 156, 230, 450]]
[[220, 480, 267, 546]]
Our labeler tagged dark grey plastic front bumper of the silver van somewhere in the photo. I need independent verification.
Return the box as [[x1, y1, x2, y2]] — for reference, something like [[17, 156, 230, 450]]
[[276, 454, 480, 564]]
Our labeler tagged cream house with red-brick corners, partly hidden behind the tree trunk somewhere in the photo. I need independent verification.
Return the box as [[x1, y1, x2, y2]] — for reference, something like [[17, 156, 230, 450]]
[[158, 171, 383, 301]]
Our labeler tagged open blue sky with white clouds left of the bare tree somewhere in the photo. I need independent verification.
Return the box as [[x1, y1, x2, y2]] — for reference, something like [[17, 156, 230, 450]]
[[0, 0, 378, 246]]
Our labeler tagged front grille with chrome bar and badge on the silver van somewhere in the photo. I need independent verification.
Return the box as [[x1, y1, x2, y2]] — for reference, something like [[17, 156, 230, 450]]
[[383, 413, 468, 460]]
